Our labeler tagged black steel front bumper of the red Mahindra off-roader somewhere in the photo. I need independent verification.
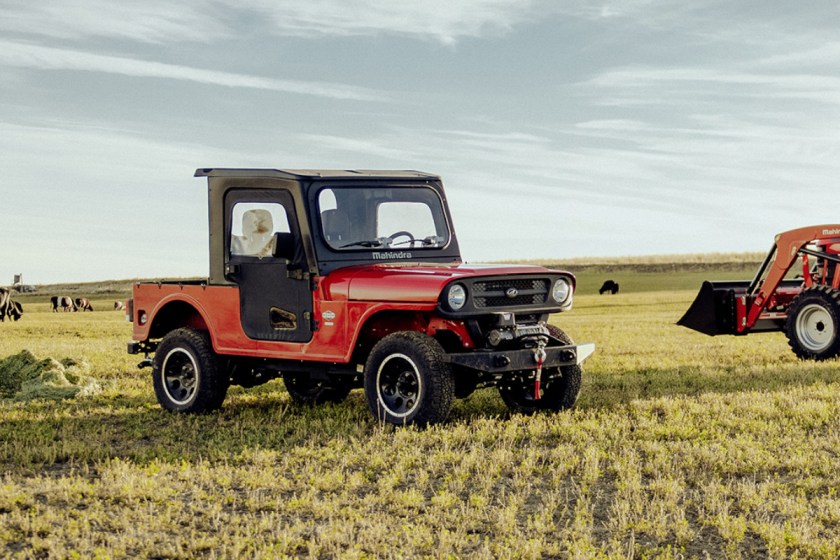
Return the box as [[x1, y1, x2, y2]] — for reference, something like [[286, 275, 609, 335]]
[[446, 342, 595, 373]]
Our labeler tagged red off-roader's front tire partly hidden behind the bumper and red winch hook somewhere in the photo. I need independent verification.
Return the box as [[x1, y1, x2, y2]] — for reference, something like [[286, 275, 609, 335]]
[[499, 325, 583, 414]]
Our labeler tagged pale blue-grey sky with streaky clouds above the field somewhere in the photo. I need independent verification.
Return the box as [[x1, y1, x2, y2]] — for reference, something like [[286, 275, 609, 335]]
[[0, 0, 840, 285]]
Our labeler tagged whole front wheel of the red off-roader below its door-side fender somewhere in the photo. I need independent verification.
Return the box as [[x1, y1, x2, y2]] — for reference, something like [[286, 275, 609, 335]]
[[365, 331, 455, 426]]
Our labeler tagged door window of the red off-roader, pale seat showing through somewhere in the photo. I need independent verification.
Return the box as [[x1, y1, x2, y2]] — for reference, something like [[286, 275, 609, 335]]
[[230, 202, 291, 258]]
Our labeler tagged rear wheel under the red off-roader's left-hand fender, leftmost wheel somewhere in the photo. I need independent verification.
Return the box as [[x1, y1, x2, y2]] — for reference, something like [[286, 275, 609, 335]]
[[152, 328, 229, 412]]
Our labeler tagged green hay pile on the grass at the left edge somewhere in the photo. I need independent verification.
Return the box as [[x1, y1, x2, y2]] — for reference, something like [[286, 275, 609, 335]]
[[0, 350, 102, 400]]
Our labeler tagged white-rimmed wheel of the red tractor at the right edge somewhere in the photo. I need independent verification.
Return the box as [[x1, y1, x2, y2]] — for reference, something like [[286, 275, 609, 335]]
[[785, 286, 840, 361]]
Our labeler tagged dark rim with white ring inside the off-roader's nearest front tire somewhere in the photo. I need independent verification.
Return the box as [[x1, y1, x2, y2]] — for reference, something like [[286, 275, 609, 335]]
[[376, 354, 423, 418]]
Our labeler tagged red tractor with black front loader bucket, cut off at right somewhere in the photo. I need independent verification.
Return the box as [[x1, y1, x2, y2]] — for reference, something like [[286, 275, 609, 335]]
[[677, 225, 840, 360]]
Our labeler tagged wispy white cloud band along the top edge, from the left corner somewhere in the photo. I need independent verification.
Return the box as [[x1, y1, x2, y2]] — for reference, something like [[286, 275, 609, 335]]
[[0, 0, 538, 44]]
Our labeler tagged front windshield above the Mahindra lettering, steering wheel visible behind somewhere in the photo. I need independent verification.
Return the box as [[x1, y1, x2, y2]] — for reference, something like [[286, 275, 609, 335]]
[[318, 187, 449, 251]]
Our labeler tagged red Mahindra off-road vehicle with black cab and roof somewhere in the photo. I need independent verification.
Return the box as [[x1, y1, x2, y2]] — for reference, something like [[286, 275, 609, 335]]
[[128, 169, 594, 424]]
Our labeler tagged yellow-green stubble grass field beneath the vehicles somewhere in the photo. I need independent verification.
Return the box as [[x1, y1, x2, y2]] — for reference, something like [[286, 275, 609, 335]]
[[0, 266, 840, 559]]
